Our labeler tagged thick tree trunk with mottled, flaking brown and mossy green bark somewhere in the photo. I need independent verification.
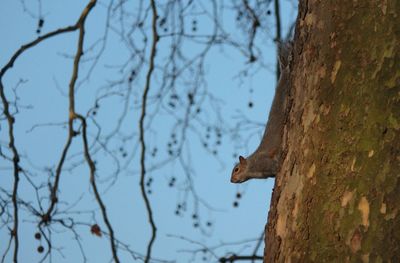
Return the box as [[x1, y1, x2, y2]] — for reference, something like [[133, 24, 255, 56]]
[[264, 0, 400, 262]]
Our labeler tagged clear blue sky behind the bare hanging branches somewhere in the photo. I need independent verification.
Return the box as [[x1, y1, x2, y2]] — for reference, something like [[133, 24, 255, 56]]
[[0, 0, 295, 262]]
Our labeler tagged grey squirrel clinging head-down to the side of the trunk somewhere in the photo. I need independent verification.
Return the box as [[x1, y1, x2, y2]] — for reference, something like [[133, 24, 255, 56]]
[[231, 41, 293, 186]]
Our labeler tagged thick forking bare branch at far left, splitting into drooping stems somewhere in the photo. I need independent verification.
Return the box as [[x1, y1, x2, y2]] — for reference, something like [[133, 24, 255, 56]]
[[0, 0, 109, 262]]
